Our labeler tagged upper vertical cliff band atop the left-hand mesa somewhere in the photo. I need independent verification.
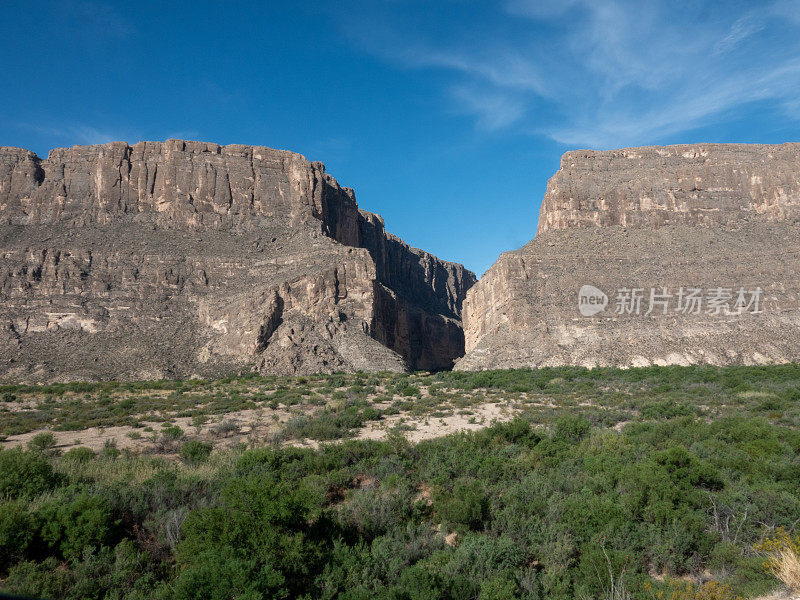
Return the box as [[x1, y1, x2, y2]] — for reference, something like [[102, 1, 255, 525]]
[[0, 140, 359, 245]]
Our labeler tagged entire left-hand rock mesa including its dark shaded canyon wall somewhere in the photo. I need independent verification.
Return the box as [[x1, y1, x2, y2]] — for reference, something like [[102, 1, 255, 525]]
[[0, 140, 475, 381]]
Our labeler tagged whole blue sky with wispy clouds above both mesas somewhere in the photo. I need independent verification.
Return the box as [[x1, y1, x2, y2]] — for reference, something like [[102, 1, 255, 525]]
[[0, 0, 800, 275]]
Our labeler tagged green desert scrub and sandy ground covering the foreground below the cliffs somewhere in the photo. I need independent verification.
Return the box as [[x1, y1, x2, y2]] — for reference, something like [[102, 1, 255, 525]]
[[0, 365, 800, 600]]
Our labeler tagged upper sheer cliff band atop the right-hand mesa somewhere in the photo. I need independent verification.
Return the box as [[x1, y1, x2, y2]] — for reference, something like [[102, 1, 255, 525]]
[[538, 144, 800, 233]]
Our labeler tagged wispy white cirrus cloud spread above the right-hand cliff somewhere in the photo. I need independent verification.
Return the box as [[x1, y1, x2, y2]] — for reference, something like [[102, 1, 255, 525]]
[[346, 0, 800, 148]]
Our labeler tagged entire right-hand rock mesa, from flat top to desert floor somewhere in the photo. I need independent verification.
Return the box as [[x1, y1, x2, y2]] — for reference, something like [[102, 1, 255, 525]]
[[456, 144, 800, 369]]
